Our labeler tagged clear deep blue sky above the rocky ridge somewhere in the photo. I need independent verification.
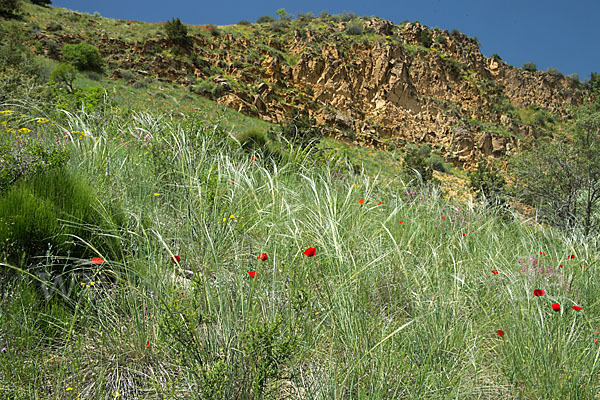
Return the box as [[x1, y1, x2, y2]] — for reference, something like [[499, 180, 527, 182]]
[[52, 0, 600, 80]]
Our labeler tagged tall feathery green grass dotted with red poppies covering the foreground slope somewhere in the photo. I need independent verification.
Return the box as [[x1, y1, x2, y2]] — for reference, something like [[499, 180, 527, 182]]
[[0, 98, 600, 399]]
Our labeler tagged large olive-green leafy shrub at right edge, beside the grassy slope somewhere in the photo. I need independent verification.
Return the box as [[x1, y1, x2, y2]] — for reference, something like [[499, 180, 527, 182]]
[[510, 105, 600, 236]]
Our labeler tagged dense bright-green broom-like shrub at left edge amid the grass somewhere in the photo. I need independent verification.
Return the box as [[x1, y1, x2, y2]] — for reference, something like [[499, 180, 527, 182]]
[[0, 168, 121, 267]]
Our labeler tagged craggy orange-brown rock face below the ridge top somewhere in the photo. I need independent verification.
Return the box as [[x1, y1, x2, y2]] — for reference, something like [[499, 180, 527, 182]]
[[44, 18, 586, 164]]
